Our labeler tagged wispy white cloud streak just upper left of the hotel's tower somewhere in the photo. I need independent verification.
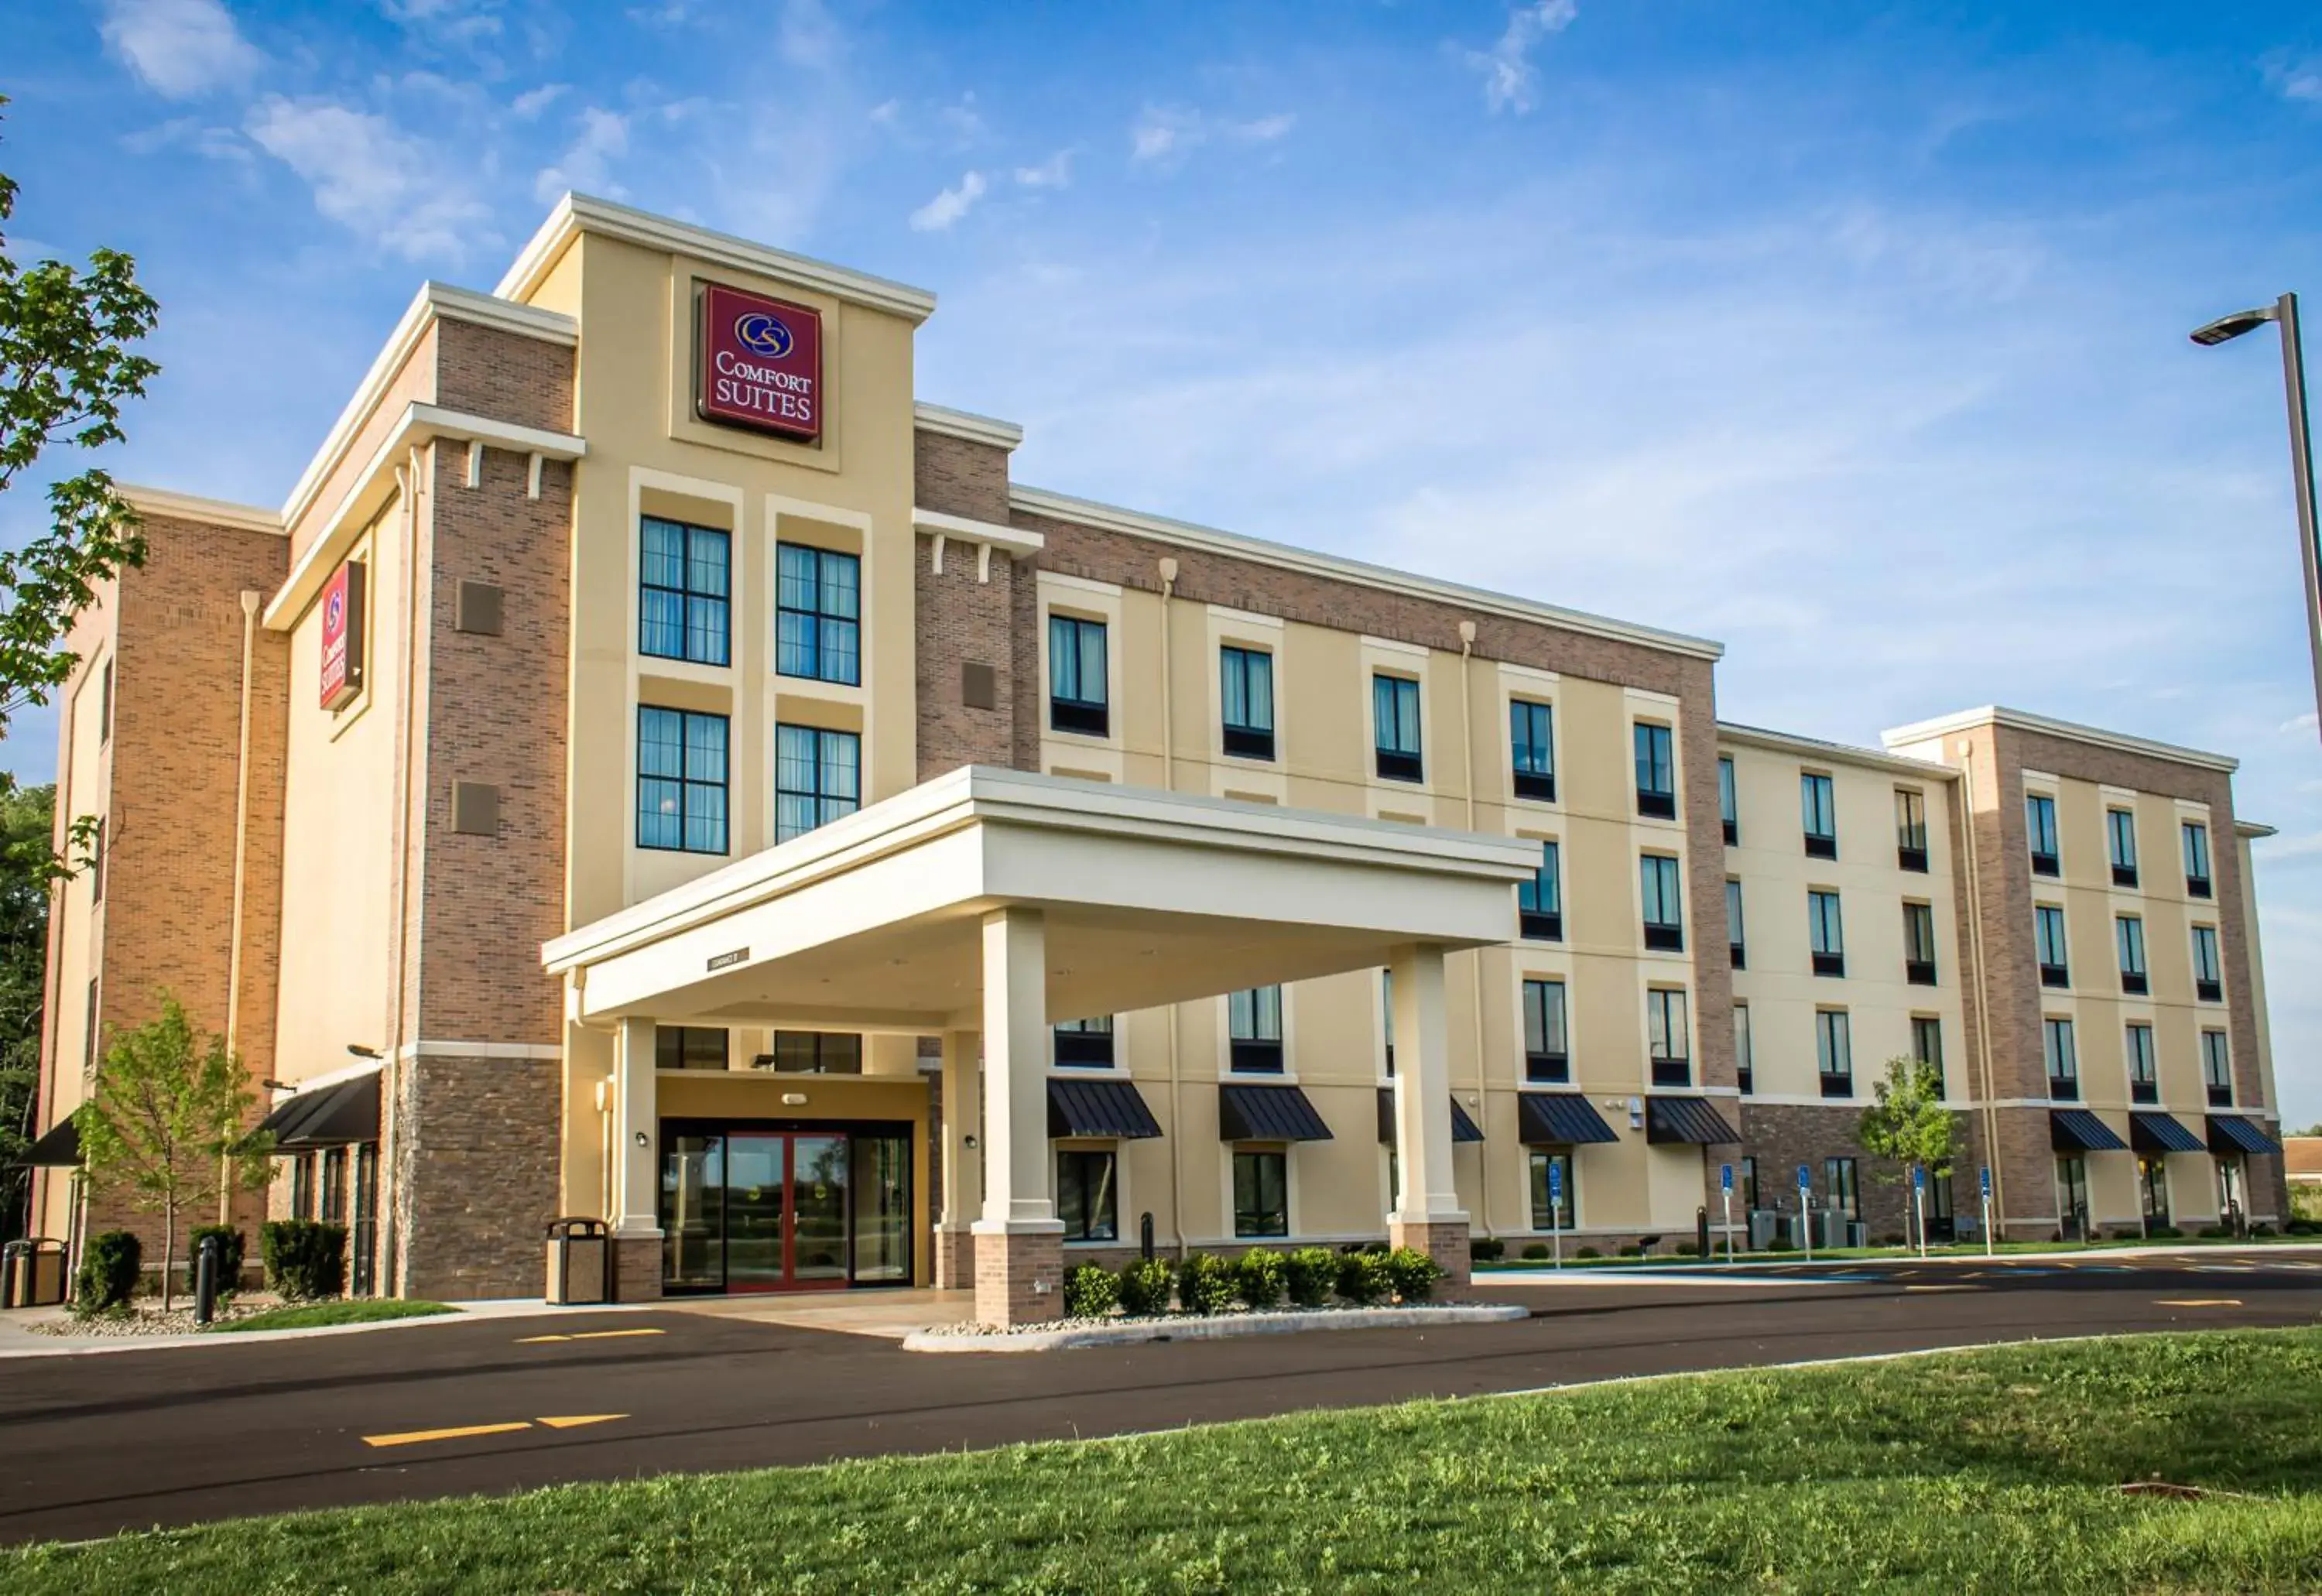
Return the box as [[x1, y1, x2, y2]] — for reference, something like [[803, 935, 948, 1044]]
[[244, 95, 490, 260]]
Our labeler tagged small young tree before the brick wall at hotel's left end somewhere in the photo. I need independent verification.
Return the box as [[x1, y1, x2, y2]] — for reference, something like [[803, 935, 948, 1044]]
[[74, 992, 274, 1313]]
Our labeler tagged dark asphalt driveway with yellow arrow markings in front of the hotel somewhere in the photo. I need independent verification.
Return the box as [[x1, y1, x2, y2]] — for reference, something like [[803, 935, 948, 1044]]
[[0, 1250, 2322, 1540]]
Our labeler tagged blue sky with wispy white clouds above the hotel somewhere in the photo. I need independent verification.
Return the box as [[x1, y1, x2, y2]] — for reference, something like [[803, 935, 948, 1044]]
[[13, 0, 2322, 1122]]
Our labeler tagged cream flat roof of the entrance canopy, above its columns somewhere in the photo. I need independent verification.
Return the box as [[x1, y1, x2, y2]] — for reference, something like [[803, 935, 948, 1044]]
[[541, 766, 1539, 1036]]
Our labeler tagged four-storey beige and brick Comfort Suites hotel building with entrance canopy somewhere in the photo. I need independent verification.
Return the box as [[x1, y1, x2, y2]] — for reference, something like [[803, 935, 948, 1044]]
[[35, 197, 2287, 1320]]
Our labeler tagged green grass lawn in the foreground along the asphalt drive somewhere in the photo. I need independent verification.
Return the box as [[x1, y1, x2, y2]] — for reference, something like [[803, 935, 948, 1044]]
[[0, 1331, 2322, 1596]]
